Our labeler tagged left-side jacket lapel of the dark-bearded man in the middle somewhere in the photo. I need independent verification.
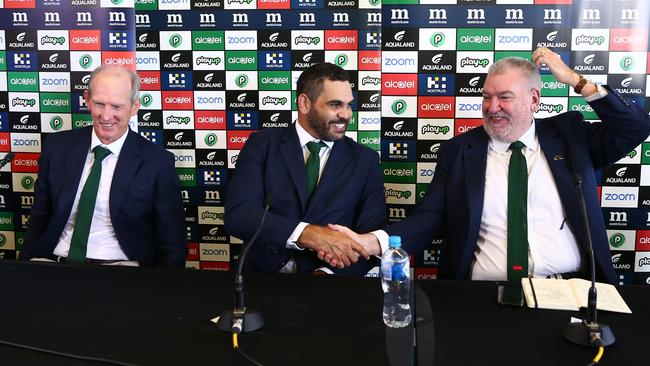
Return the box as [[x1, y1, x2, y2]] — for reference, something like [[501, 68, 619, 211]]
[[279, 127, 307, 212]]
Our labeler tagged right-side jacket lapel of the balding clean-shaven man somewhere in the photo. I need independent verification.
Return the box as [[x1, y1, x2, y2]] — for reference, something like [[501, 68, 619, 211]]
[[109, 130, 142, 216]]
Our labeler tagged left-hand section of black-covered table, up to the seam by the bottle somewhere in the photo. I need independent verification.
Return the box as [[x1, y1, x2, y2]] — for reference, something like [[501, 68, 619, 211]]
[[0, 261, 413, 366]]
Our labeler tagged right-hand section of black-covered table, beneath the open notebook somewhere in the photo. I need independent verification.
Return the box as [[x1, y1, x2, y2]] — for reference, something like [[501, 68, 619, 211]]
[[415, 280, 650, 366]]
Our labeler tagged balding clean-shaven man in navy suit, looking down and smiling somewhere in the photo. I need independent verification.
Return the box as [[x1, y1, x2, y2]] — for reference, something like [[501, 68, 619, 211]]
[[21, 67, 187, 267]]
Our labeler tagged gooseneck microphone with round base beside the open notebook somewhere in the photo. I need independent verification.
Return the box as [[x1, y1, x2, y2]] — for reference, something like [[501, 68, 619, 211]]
[[562, 174, 616, 347]]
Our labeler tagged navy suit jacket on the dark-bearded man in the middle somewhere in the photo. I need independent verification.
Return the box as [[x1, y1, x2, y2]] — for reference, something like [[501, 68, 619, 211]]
[[225, 125, 386, 275]]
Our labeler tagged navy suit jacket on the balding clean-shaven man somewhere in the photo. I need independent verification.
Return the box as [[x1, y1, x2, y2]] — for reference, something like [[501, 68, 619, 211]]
[[21, 126, 187, 267]]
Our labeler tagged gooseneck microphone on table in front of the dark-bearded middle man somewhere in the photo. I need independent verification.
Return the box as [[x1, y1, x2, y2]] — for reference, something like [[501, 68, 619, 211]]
[[217, 196, 271, 334]]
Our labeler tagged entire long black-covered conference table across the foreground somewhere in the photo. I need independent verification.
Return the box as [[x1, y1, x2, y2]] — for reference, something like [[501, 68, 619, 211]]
[[0, 260, 650, 366]]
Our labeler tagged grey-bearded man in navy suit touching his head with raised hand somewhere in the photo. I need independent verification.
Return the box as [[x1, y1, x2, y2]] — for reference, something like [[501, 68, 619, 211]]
[[330, 48, 650, 282]]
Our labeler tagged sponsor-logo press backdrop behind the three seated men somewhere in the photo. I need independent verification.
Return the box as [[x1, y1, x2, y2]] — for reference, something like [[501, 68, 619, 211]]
[[0, 0, 650, 284]]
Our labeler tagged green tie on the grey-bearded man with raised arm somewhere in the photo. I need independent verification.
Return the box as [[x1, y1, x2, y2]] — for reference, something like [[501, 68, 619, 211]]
[[508, 141, 528, 281]]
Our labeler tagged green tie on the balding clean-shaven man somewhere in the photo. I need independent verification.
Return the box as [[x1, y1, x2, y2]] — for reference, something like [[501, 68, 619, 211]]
[[68, 146, 111, 263]]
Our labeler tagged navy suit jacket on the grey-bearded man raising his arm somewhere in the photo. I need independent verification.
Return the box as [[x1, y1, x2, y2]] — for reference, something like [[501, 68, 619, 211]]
[[386, 89, 650, 282]]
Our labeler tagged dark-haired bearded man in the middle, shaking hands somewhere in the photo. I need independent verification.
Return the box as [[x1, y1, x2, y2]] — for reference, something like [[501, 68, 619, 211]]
[[224, 63, 386, 275]]
